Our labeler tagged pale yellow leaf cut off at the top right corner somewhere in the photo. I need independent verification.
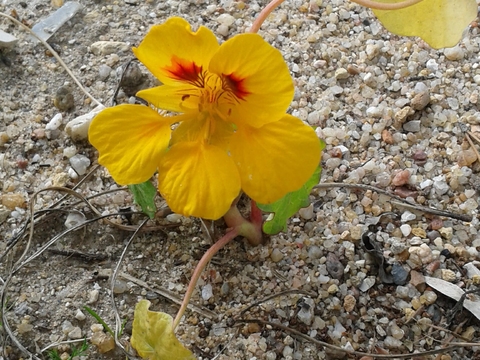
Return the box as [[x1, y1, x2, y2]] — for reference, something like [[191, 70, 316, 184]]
[[373, 0, 477, 49]]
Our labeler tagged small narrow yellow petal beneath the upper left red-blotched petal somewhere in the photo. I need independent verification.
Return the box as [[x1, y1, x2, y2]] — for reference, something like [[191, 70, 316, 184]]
[[136, 83, 199, 113]]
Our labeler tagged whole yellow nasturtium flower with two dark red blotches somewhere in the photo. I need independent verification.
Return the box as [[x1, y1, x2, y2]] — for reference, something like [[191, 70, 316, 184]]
[[89, 17, 320, 219]]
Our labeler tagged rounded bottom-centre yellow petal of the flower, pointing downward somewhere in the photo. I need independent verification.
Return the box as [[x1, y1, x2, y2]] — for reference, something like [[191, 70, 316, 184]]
[[158, 142, 240, 220]]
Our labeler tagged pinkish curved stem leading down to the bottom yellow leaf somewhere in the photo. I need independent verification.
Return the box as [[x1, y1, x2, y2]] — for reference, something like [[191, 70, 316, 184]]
[[173, 228, 239, 331]]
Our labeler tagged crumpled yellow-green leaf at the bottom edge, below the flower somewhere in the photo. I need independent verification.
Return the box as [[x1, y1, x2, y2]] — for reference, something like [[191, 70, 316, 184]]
[[130, 300, 195, 360]]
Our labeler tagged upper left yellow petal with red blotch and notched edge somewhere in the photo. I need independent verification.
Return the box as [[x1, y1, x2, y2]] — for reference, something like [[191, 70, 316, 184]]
[[133, 17, 219, 84]]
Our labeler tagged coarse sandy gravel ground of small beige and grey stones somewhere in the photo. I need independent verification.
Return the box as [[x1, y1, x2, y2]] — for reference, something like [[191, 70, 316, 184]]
[[0, 0, 480, 360]]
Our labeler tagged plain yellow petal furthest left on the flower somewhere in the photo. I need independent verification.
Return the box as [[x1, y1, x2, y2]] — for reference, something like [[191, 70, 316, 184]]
[[88, 104, 174, 185]]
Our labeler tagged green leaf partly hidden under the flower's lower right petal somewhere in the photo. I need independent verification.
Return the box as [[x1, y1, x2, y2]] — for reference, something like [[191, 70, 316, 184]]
[[257, 141, 325, 235]]
